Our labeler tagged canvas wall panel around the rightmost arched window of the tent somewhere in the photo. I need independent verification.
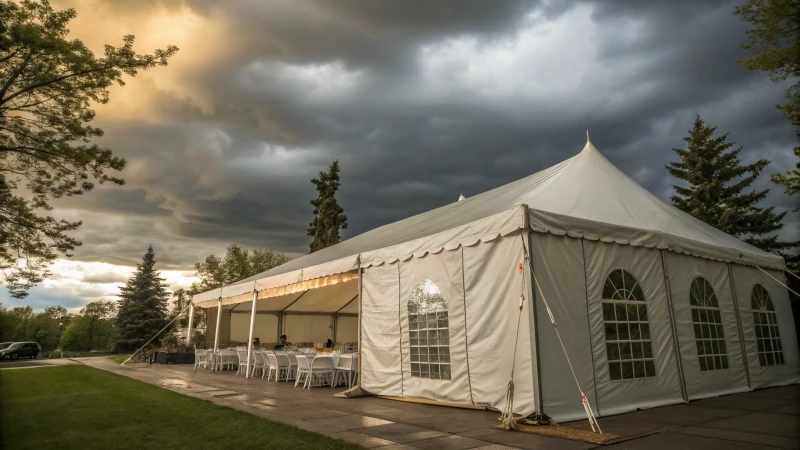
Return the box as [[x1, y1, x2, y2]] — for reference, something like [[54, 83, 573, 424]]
[[731, 264, 800, 389]]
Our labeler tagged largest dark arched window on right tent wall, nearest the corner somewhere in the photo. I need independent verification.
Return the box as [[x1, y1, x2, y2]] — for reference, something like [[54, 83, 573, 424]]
[[603, 269, 656, 380]]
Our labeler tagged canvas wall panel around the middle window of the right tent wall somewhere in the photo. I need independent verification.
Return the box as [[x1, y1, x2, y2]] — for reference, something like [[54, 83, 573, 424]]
[[664, 252, 748, 400]]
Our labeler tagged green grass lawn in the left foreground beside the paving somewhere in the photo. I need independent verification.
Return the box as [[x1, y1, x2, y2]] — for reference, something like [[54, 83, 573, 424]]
[[0, 365, 361, 450]]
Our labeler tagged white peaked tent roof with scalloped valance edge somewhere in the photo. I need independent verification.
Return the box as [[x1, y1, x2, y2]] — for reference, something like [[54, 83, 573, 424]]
[[194, 143, 785, 307]]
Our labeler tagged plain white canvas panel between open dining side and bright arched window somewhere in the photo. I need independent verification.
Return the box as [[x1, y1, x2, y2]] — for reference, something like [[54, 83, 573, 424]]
[[359, 263, 403, 396]]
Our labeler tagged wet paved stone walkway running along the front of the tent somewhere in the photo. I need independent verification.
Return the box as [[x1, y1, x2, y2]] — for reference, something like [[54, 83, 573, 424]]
[[77, 357, 800, 450]]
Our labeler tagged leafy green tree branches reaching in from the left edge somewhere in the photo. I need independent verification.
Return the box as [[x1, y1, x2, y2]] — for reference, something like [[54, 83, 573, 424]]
[[0, 0, 178, 298]]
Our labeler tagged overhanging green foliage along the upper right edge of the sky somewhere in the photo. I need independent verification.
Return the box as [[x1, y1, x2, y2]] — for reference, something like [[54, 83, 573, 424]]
[[736, 0, 800, 202]]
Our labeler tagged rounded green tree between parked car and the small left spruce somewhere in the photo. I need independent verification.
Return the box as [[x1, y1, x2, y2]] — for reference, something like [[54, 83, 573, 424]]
[[61, 301, 118, 351]]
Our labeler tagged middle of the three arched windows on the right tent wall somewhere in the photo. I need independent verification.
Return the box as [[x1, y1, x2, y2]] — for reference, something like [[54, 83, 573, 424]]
[[689, 277, 728, 372]]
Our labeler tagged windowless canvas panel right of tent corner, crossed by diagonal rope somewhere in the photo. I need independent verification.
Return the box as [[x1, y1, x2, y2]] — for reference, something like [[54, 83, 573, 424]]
[[532, 233, 597, 420]]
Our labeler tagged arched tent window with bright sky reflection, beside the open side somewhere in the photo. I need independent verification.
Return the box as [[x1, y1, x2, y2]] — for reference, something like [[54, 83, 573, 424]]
[[408, 280, 450, 380]]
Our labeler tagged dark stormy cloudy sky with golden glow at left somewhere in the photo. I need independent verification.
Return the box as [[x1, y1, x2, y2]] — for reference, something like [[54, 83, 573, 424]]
[[0, 0, 800, 309]]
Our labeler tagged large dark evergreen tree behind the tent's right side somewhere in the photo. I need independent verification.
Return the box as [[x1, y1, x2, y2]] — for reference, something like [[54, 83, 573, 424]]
[[667, 115, 798, 256]]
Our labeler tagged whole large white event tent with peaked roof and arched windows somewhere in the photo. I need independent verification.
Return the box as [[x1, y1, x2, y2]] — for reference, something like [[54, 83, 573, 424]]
[[192, 141, 800, 421]]
